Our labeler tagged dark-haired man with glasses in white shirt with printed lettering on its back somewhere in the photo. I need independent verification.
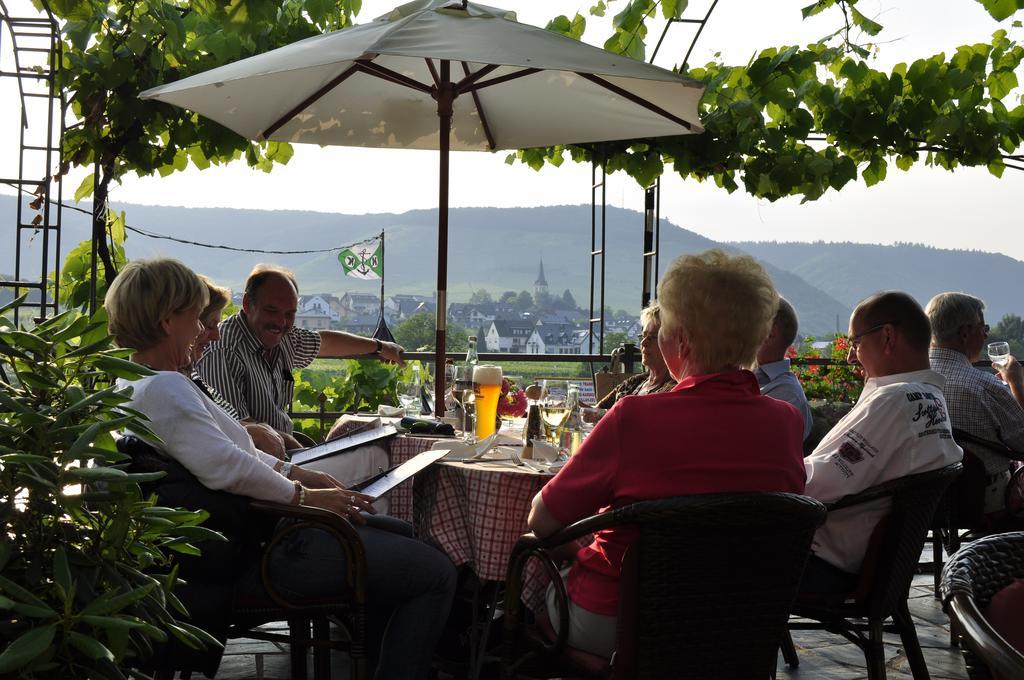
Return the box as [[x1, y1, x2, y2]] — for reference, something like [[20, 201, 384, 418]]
[[801, 291, 963, 594]]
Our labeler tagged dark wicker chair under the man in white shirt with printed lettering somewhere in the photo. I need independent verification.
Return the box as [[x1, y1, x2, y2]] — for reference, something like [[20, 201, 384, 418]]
[[782, 463, 963, 680]]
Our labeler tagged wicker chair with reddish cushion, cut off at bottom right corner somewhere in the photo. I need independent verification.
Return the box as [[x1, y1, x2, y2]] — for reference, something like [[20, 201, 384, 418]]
[[942, 532, 1024, 680]]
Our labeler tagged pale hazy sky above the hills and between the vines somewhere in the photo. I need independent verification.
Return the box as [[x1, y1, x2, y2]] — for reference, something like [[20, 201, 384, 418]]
[[0, 0, 1024, 260]]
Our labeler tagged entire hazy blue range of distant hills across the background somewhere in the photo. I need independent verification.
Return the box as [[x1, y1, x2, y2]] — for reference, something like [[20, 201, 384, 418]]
[[0, 196, 1024, 335]]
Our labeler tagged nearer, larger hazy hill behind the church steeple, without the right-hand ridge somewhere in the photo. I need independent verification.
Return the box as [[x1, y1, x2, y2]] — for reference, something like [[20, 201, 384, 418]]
[[0, 197, 849, 334]]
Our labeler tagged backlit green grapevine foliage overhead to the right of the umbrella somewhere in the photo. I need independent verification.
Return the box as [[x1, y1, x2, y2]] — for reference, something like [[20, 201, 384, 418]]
[[520, 0, 1024, 196]]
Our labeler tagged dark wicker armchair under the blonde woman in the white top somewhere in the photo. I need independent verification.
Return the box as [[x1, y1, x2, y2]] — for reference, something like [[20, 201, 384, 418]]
[[118, 435, 368, 680]]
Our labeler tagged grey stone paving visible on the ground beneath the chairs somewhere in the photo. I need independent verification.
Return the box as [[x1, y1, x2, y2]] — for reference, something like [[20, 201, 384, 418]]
[[211, 575, 967, 680]]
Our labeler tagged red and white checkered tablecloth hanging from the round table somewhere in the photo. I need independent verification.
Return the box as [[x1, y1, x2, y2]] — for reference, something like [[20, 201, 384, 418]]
[[391, 436, 551, 581]]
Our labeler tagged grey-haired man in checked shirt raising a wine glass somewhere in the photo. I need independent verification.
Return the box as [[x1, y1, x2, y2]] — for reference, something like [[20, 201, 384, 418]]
[[927, 293, 1024, 513]]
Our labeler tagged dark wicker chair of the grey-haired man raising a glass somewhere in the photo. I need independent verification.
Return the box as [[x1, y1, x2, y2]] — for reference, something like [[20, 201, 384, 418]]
[[932, 428, 1024, 597]]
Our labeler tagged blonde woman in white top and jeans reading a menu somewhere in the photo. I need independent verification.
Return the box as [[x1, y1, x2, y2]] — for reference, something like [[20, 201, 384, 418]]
[[105, 259, 456, 679]]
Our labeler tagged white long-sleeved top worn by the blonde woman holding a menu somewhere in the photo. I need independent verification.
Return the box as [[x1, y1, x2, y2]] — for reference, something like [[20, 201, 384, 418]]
[[118, 371, 295, 503]]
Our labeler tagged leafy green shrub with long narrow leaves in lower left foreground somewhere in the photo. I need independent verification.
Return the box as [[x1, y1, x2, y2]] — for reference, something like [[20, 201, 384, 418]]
[[0, 298, 219, 678]]
